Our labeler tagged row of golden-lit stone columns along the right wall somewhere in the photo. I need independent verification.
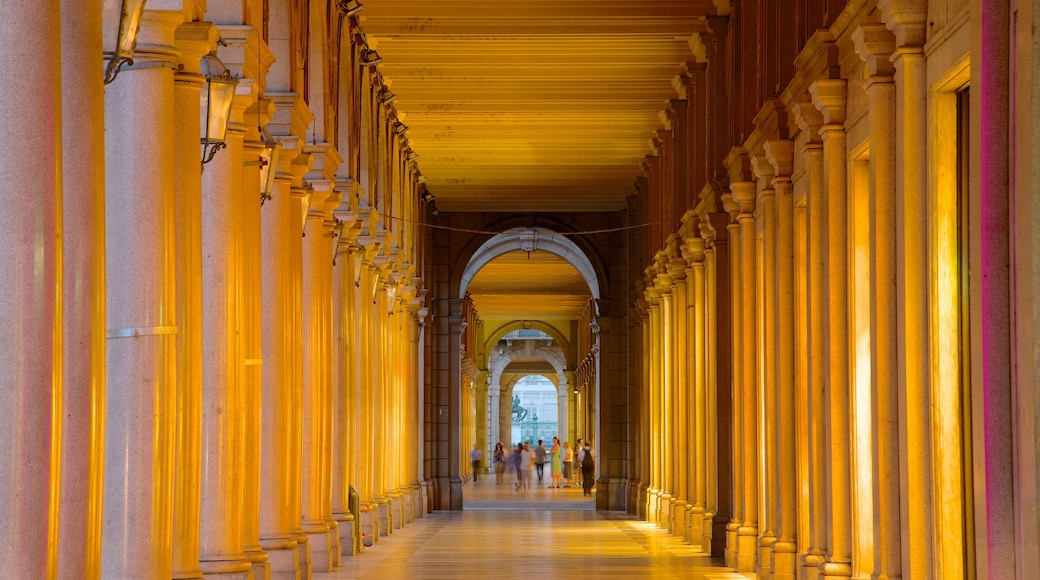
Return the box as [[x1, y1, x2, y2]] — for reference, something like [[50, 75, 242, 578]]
[[629, 1, 1030, 579]]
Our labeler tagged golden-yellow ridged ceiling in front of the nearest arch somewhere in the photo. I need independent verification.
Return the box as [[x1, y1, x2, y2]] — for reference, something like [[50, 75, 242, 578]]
[[360, 0, 728, 212]]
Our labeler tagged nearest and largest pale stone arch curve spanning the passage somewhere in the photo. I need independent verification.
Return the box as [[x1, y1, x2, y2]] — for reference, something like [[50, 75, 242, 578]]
[[458, 228, 601, 315]]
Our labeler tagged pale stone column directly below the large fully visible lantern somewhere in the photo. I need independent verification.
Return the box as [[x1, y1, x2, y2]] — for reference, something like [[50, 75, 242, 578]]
[[199, 79, 253, 580]]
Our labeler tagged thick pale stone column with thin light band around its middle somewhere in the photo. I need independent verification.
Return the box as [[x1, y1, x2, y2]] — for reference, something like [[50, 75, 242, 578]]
[[101, 10, 183, 579]]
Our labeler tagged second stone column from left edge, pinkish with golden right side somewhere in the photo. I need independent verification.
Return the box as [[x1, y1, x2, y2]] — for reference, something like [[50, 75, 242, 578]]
[[57, 0, 105, 578]]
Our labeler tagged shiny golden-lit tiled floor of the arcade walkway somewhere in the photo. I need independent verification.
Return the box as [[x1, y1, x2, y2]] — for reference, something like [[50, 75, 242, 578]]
[[315, 476, 746, 580]]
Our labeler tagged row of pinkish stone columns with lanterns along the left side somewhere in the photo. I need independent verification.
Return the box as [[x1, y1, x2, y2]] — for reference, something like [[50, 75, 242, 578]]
[[0, 0, 426, 579]]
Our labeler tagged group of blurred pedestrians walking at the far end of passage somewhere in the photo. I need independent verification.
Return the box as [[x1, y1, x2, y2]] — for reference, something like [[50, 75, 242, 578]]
[[482, 437, 596, 496]]
